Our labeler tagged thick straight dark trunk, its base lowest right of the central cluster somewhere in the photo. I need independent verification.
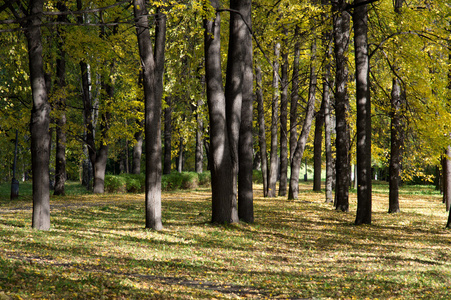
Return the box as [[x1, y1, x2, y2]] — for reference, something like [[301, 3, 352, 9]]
[[353, 0, 372, 225]]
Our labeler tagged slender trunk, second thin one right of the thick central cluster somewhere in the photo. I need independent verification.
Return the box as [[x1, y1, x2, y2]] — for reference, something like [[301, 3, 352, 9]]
[[268, 43, 280, 198]]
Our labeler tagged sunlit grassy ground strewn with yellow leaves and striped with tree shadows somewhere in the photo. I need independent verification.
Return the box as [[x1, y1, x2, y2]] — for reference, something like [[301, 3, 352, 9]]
[[0, 182, 451, 300]]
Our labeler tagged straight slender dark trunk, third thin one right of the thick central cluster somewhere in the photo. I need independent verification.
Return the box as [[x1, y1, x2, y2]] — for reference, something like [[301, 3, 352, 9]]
[[279, 28, 288, 196]]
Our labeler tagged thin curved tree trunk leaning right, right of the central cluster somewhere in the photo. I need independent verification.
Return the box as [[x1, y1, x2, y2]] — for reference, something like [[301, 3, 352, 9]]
[[288, 40, 317, 199]]
